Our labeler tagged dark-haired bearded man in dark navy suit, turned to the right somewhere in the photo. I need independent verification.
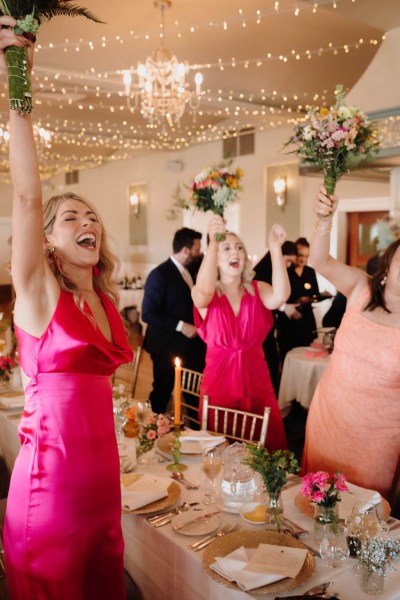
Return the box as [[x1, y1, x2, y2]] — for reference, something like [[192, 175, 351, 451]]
[[142, 227, 206, 413]]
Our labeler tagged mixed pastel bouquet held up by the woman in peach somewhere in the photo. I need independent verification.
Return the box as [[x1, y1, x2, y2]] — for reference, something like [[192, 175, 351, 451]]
[[285, 85, 379, 195]]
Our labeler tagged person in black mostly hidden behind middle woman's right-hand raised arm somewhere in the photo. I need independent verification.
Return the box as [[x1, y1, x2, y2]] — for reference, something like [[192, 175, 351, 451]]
[[254, 241, 296, 397]]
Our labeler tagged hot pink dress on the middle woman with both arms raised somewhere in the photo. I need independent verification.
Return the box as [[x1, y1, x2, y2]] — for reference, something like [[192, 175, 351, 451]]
[[195, 281, 287, 450]]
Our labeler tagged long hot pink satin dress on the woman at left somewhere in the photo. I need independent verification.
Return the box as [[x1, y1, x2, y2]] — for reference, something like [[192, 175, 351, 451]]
[[4, 291, 132, 600]]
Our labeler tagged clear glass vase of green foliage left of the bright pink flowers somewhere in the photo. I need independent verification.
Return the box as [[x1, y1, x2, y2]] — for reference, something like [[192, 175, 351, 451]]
[[243, 444, 300, 531]]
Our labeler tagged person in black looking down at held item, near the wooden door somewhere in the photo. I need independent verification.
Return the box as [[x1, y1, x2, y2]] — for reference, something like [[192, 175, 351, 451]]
[[278, 238, 320, 363]]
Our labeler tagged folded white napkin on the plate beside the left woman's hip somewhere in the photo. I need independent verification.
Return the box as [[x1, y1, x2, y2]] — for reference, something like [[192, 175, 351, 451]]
[[121, 474, 171, 510]]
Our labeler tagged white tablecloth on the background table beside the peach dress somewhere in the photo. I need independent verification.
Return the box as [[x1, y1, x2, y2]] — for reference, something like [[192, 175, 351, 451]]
[[278, 347, 330, 417]]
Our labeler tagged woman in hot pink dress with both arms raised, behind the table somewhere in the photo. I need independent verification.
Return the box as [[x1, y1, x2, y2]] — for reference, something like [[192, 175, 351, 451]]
[[192, 216, 290, 450]]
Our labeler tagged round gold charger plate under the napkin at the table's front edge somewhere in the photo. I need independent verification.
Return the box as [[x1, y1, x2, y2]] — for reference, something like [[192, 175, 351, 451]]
[[202, 531, 315, 594]]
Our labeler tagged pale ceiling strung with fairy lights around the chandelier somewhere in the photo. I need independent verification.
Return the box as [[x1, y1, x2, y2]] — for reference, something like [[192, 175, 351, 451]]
[[0, 0, 400, 176]]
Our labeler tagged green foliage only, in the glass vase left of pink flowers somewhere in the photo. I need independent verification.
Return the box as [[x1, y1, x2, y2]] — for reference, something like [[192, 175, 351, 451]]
[[243, 444, 300, 494]]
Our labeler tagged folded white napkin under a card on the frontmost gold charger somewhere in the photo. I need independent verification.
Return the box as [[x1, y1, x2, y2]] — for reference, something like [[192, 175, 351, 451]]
[[210, 546, 284, 592]]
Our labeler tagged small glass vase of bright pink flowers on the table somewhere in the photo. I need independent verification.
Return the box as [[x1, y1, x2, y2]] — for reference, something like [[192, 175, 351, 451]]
[[301, 471, 348, 541]]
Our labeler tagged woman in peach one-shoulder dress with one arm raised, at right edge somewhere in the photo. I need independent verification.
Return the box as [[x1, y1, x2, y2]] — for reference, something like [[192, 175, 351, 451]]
[[302, 186, 400, 500]]
